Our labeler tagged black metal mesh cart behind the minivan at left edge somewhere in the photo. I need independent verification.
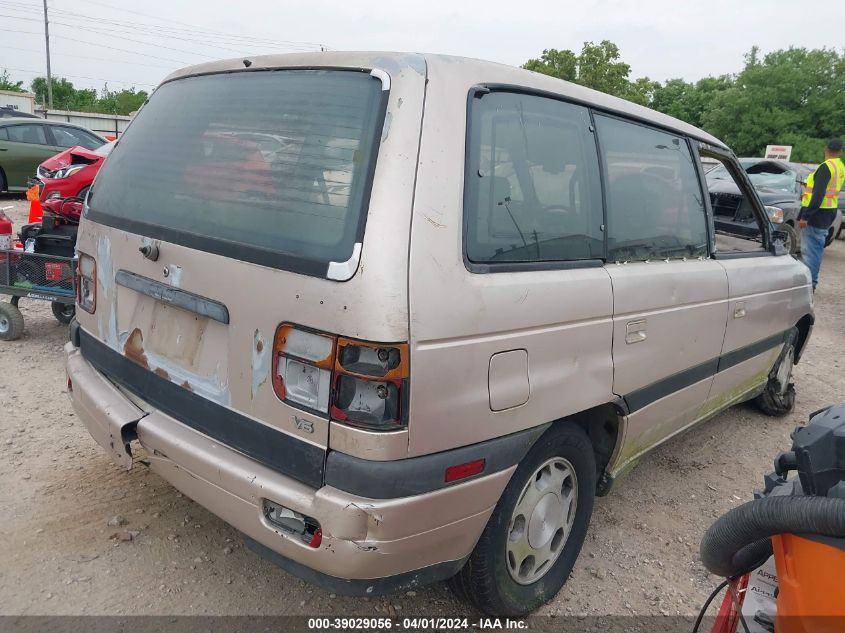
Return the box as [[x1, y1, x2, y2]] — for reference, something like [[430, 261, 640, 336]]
[[0, 249, 76, 341]]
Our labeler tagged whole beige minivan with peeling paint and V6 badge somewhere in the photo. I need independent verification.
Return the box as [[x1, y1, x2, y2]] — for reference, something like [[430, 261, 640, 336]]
[[62, 52, 813, 615]]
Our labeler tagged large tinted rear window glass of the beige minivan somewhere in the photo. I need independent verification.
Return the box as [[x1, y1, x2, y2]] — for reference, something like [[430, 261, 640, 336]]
[[88, 70, 385, 277]]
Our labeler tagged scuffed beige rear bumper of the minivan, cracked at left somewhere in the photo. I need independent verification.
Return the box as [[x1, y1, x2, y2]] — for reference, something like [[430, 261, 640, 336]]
[[65, 343, 515, 595]]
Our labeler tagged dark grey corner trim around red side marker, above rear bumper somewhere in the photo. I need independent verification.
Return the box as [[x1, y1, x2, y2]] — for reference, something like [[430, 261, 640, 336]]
[[326, 424, 551, 499]]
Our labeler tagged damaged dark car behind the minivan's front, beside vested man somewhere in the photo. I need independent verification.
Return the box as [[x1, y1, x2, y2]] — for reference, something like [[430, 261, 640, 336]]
[[707, 158, 842, 254]]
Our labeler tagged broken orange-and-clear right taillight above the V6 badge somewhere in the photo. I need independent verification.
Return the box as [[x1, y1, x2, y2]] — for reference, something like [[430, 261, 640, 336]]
[[273, 323, 409, 431]]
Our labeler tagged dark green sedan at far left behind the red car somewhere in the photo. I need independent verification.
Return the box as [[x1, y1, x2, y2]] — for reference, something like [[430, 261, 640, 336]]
[[0, 118, 106, 191]]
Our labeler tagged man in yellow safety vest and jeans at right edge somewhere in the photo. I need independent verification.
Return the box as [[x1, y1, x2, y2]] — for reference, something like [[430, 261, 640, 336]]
[[798, 138, 845, 291]]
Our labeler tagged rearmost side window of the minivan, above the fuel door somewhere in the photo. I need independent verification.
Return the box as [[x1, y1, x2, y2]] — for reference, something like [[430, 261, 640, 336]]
[[465, 92, 604, 270]]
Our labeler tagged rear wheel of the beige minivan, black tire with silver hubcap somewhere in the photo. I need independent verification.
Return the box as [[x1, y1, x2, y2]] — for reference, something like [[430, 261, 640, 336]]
[[451, 422, 596, 617]]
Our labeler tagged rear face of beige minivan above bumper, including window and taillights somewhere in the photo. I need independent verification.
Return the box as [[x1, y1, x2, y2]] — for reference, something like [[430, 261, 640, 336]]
[[71, 56, 425, 488]]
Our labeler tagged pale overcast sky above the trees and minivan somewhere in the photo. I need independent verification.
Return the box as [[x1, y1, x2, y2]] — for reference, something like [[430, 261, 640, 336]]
[[0, 0, 845, 95]]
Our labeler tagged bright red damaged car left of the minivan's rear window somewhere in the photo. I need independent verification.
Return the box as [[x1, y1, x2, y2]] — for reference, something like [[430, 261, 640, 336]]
[[30, 141, 115, 202]]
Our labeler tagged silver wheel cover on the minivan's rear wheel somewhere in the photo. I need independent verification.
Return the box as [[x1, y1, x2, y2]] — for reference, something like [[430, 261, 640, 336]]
[[505, 457, 578, 585]]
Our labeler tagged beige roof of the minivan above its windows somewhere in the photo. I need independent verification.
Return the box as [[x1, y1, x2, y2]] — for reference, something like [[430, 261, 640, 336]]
[[162, 51, 728, 149]]
